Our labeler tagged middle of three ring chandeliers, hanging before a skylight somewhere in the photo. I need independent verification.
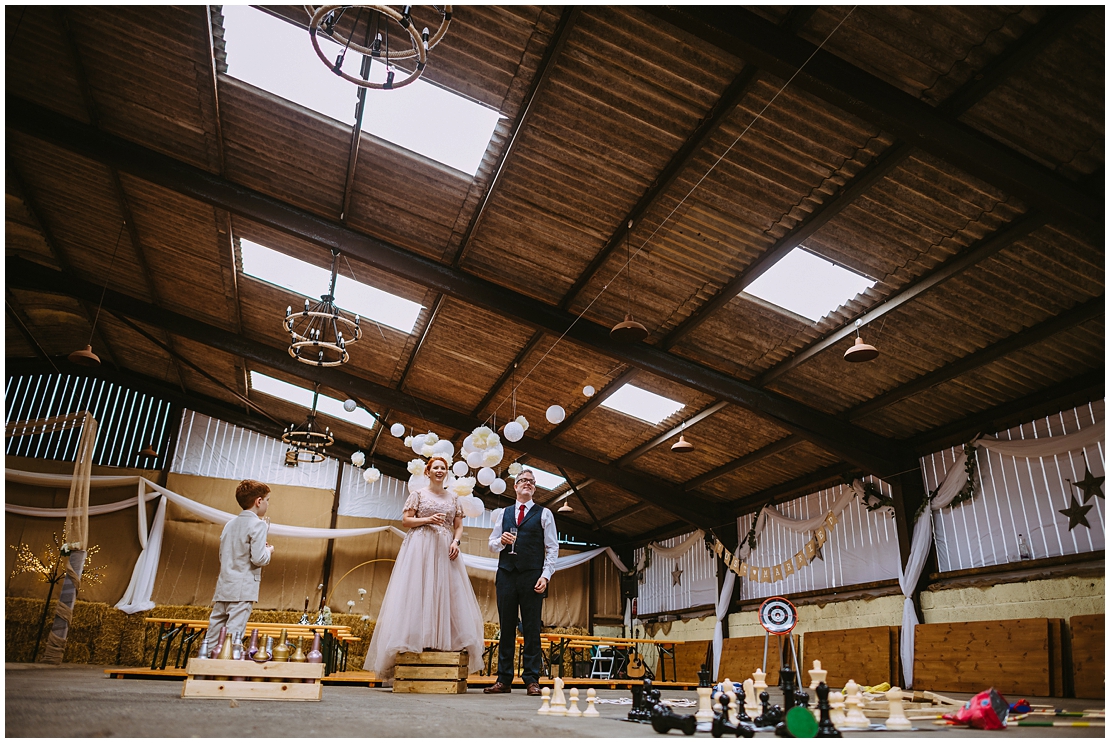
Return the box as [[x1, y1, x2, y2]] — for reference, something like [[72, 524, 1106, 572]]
[[284, 250, 362, 364]]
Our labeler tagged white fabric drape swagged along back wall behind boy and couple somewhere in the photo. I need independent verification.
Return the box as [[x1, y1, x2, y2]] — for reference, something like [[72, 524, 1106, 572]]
[[4, 470, 626, 614]]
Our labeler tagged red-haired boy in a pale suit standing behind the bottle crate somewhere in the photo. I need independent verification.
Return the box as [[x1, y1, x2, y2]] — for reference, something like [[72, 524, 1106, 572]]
[[206, 480, 274, 652]]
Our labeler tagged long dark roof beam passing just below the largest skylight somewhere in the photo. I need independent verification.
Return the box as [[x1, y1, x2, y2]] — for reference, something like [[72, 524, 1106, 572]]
[[6, 93, 909, 474]]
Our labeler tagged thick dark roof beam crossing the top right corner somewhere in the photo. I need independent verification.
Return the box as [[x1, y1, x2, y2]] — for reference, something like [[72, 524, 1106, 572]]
[[642, 6, 1104, 233]]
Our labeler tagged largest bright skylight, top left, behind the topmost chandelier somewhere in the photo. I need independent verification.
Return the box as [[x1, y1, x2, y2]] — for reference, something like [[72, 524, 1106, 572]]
[[223, 6, 501, 175]]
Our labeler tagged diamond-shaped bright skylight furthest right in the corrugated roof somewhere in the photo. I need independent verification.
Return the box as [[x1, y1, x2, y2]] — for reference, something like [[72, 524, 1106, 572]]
[[744, 248, 875, 322]]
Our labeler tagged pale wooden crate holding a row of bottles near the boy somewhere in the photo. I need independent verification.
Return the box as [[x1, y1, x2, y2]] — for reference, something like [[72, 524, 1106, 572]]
[[181, 657, 324, 702]]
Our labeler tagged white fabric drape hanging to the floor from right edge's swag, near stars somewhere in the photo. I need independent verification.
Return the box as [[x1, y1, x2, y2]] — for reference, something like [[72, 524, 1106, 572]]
[[898, 422, 1104, 689]]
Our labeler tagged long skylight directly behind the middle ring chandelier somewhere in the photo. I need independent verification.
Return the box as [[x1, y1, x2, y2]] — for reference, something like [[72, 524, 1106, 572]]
[[240, 240, 424, 333]]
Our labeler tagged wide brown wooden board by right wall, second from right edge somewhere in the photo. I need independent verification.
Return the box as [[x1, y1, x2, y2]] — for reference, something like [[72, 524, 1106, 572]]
[[914, 619, 1063, 696]]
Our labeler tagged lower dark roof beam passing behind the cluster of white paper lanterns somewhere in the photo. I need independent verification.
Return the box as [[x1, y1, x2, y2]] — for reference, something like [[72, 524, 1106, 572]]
[[13, 258, 716, 525]]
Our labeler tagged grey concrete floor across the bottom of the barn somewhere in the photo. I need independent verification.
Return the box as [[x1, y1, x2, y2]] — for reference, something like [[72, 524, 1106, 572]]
[[4, 663, 1104, 740]]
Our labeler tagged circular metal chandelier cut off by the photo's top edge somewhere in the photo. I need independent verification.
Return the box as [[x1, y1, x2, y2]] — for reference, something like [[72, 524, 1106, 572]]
[[306, 6, 452, 90]]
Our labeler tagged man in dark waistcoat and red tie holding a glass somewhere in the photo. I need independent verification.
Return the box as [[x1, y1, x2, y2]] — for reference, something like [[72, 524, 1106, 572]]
[[484, 470, 558, 696]]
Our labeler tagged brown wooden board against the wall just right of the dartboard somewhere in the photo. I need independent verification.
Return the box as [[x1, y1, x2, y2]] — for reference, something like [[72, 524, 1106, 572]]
[[799, 625, 901, 687]]
